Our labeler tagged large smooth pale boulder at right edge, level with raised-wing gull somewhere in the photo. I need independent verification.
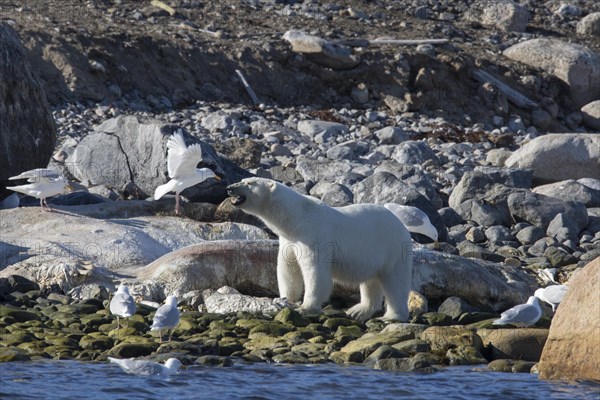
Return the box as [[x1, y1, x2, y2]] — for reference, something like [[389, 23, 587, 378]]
[[505, 133, 600, 184]]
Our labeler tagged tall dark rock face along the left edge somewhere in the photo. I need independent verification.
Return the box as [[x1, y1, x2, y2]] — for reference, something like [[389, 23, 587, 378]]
[[0, 24, 56, 200]]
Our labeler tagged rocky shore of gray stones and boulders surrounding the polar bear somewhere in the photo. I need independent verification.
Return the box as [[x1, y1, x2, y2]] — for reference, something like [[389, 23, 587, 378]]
[[0, 0, 600, 379]]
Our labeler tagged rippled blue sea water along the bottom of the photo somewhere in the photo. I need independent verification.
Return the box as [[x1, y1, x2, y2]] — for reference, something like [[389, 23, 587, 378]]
[[0, 361, 600, 400]]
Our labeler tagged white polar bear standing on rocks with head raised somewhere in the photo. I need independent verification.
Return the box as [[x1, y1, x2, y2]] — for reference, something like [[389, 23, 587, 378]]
[[227, 178, 412, 321]]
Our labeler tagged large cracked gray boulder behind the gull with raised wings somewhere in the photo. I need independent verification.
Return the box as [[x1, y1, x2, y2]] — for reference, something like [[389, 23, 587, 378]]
[[67, 115, 249, 204]]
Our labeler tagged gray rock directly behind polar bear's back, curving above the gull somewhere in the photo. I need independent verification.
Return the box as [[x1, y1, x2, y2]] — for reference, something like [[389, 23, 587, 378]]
[[352, 172, 447, 241]]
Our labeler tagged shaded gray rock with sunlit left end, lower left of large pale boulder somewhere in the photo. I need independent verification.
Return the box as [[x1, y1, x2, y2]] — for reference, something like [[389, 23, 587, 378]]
[[448, 167, 532, 210]]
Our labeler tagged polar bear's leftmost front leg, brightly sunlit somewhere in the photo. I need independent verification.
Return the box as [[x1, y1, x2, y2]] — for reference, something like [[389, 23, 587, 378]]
[[277, 240, 304, 303]]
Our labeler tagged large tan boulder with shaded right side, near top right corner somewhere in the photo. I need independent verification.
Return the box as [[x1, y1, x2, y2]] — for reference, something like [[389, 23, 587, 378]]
[[504, 38, 600, 106]]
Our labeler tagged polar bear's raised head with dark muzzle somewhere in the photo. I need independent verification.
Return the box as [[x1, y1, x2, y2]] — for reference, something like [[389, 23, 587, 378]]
[[227, 178, 277, 214]]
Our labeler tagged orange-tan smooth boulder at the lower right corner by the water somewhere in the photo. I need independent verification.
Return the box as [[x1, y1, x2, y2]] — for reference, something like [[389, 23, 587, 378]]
[[538, 258, 600, 381]]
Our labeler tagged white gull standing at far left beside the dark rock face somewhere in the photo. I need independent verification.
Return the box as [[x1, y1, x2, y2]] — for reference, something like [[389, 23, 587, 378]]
[[6, 168, 71, 211]]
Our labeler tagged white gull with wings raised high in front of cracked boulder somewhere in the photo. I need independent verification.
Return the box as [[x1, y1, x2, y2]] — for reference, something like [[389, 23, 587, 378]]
[[154, 130, 221, 214]]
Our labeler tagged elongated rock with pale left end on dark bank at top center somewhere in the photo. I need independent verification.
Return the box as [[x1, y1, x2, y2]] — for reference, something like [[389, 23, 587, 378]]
[[283, 30, 360, 70]]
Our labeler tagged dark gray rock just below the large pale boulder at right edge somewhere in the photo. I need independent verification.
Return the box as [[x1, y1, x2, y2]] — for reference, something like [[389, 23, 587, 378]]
[[508, 193, 588, 231]]
